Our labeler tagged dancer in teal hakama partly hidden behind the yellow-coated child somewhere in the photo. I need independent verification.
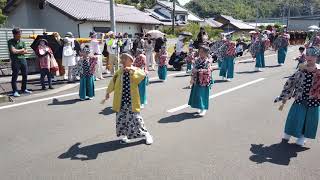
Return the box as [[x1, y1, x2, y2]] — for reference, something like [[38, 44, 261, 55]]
[[133, 49, 149, 109]]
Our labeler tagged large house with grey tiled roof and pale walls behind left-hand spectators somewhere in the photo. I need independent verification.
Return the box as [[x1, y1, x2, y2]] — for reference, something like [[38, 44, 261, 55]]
[[4, 0, 161, 37]]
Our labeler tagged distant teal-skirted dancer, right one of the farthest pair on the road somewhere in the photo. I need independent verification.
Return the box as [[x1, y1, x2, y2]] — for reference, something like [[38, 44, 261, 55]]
[[274, 32, 289, 66]]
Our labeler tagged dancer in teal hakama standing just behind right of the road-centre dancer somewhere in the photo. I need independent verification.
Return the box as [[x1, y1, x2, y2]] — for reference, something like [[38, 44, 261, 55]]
[[219, 34, 236, 81]]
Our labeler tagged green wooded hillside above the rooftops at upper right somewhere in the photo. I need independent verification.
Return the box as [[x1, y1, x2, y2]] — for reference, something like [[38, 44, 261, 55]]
[[185, 0, 320, 19]]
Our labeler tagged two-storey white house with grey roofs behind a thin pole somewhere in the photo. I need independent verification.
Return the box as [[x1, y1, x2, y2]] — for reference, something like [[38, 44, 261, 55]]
[[145, 0, 203, 26]]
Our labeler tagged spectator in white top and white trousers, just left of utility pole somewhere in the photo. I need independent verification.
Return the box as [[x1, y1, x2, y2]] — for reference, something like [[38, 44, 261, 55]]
[[90, 31, 104, 81]]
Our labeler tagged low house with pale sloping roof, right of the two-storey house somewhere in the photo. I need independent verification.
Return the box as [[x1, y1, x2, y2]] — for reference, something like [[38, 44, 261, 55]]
[[214, 15, 255, 32]]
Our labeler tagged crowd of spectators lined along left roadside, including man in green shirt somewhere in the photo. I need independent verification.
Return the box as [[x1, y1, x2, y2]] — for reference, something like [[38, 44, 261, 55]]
[[8, 28, 167, 97]]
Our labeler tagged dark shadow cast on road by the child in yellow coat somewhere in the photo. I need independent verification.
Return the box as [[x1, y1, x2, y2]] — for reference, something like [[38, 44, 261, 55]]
[[58, 140, 145, 161]]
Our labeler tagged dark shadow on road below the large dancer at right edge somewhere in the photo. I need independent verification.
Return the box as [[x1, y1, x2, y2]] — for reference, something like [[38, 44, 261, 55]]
[[249, 141, 309, 166]]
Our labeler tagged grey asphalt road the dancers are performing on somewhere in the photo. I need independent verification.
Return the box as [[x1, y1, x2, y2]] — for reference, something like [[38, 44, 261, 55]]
[[0, 47, 320, 180]]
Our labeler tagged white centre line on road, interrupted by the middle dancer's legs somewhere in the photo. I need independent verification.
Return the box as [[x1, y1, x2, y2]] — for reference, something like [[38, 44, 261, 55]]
[[167, 78, 265, 113]]
